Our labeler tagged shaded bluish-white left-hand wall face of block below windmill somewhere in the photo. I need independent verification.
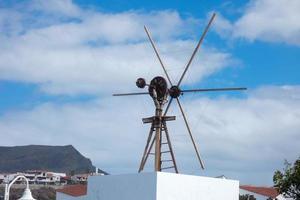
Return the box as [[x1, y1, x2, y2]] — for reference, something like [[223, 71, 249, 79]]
[[86, 173, 156, 200]]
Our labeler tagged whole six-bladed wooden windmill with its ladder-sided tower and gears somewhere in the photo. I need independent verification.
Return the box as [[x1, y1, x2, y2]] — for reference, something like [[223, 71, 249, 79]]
[[113, 13, 246, 173]]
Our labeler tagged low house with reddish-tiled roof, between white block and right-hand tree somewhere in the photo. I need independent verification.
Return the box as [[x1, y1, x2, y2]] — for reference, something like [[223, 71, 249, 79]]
[[240, 185, 285, 200]]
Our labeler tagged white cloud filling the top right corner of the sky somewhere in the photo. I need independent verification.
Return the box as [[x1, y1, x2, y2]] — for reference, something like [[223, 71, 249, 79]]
[[216, 0, 300, 46]]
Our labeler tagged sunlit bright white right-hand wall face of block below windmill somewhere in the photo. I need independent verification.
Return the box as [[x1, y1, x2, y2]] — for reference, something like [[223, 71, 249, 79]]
[[157, 172, 239, 200]]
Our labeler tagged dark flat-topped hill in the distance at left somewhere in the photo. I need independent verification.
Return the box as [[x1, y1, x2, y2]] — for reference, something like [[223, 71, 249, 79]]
[[0, 145, 107, 174]]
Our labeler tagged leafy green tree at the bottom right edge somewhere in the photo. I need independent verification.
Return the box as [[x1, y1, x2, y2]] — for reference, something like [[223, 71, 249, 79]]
[[273, 157, 300, 199]]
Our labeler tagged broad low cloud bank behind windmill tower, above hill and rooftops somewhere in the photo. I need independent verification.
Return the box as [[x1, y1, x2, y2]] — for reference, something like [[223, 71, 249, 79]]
[[0, 86, 300, 184]]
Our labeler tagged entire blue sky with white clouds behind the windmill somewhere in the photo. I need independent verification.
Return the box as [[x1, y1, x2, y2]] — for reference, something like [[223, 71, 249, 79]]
[[0, 0, 300, 185]]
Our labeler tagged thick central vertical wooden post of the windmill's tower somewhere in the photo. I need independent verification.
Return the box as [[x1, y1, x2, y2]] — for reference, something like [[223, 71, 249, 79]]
[[154, 104, 162, 171]]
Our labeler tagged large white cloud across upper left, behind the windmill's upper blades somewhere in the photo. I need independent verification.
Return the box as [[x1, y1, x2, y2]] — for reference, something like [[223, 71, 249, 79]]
[[0, 1, 233, 95]]
